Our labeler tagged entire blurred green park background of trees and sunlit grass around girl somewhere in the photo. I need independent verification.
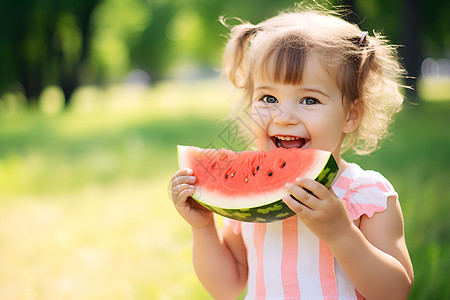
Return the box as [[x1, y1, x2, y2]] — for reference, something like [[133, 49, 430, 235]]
[[0, 0, 450, 300]]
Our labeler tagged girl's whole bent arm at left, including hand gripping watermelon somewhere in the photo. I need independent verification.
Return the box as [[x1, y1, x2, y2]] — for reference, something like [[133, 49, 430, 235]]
[[172, 169, 248, 299]]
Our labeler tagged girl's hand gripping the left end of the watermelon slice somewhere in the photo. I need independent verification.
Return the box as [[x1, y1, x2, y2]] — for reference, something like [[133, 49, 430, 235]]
[[172, 169, 213, 227]]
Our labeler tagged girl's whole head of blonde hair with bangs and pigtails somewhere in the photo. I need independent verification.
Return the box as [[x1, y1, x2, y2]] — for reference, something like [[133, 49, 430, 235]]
[[222, 4, 405, 154]]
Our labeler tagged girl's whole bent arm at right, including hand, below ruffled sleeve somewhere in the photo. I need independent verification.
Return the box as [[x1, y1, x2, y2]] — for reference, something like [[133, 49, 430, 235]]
[[283, 179, 413, 299]]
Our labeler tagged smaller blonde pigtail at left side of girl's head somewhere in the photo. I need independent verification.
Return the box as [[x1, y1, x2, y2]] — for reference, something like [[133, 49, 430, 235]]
[[220, 18, 260, 88]]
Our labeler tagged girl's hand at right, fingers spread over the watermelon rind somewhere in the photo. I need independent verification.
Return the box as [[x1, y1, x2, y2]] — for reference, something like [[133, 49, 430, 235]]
[[283, 178, 352, 243]]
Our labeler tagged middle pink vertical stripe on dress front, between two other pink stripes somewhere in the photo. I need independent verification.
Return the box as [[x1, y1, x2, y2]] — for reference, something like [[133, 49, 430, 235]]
[[281, 217, 300, 299]]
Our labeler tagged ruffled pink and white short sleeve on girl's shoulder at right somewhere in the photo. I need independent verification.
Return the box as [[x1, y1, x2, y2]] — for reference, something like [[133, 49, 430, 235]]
[[333, 164, 398, 220]]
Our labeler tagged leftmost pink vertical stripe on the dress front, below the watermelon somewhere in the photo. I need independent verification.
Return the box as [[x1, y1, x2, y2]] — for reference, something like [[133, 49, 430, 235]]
[[253, 223, 266, 299]]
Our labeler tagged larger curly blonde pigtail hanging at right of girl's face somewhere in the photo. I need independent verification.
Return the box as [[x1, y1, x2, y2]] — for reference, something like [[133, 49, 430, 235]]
[[348, 33, 405, 154]]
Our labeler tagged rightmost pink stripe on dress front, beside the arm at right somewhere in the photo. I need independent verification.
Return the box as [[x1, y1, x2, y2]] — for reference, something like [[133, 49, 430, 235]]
[[319, 240, 338, 300]]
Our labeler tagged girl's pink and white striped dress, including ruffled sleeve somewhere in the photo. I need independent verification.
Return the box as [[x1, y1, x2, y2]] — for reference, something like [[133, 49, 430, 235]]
[[224, 164, 397, 300]]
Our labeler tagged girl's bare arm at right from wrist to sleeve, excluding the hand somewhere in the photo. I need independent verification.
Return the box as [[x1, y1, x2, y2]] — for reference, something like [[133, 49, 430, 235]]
[[328, 197, 414, 299]]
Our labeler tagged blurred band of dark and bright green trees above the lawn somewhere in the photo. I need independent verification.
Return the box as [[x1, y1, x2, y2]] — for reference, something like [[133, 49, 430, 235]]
[[0, 0, 450, 105]]
